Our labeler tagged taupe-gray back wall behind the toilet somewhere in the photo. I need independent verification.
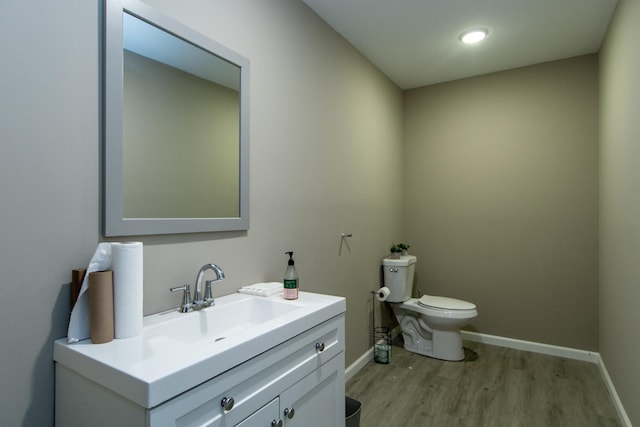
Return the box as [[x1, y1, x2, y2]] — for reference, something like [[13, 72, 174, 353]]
[[404, 55, 598, 350]]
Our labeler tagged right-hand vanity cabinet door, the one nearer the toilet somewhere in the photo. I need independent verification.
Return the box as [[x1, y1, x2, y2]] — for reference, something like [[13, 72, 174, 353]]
[[280, 353, 345, 427]]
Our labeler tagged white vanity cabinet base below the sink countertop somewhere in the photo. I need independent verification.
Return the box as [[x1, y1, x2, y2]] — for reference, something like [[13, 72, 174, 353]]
[[56, 313, 345, 427]]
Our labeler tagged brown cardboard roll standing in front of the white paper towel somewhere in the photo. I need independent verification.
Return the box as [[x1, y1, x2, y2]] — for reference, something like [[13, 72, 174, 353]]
[[88, 270, 113, 344]]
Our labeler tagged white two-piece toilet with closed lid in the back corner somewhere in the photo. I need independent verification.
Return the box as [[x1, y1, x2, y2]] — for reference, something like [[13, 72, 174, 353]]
[[382, 255, 478, 360]]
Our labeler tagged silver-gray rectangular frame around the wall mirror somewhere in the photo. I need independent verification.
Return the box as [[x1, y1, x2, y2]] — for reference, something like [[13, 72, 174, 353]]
[[102, 0, 249, 237]]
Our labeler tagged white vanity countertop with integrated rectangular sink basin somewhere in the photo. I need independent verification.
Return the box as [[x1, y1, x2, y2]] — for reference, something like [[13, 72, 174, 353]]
[[53, 292, 346, 408]]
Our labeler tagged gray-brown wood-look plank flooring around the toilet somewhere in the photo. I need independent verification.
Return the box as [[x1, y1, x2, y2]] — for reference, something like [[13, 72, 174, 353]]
[[346, 339, 622, 427]]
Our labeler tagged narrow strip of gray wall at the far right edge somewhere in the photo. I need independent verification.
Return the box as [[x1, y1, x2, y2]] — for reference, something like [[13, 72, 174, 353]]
[[600, 1, 640, 425]]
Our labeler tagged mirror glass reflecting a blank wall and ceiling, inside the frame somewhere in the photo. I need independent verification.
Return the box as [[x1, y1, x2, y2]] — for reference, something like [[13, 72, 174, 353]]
[[122, 13, 240, 218]]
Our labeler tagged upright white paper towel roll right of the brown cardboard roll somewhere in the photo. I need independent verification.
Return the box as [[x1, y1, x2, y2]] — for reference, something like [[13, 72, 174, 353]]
[[111, 242, 143, 338]]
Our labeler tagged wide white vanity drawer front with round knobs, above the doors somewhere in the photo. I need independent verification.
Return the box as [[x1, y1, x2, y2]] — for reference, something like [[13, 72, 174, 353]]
[[149, 314, 344, 427]]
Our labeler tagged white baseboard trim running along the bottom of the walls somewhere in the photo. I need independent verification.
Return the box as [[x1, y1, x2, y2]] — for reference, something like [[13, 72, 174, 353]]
[[345, 327, 633, 427]]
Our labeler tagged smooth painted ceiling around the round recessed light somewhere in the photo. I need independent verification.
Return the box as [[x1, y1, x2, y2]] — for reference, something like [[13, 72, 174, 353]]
[[303, 0, 617, 89]]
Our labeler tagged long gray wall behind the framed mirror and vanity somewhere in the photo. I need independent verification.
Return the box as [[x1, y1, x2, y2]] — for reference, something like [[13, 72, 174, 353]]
[[0, 0, 402, 427]]
